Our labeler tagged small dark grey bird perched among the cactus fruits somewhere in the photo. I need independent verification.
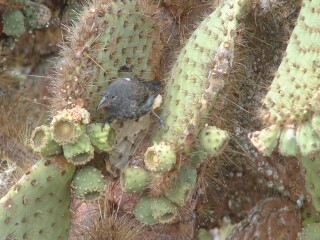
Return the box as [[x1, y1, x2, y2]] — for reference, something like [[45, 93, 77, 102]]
[[97, 78, 160, 122]]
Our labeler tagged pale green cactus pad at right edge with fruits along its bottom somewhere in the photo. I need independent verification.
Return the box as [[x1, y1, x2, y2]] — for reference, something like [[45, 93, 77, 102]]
[[249, 0, 320, 157]]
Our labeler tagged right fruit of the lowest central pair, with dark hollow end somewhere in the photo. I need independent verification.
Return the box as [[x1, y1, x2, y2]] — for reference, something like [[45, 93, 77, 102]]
[[151, 197, 178, 224]]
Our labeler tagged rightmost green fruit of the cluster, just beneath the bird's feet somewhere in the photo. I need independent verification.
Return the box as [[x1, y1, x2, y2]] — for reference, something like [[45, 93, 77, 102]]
[[86, 123, 116, 152]]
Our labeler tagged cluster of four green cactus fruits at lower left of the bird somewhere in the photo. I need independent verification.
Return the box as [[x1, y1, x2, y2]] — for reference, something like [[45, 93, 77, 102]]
[[31, 106, 115, 165]]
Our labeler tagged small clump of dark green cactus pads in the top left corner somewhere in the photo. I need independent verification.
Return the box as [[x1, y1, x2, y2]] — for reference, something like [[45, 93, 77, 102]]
[[3, 0, 51, 37]]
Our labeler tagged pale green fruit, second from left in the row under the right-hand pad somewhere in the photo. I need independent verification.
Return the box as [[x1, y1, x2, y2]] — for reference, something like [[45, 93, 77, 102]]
[[278, 126, 300, 157]]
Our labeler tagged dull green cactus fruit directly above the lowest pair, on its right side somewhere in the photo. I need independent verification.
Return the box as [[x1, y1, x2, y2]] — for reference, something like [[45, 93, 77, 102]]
[[165, 165, 197, 206]]
